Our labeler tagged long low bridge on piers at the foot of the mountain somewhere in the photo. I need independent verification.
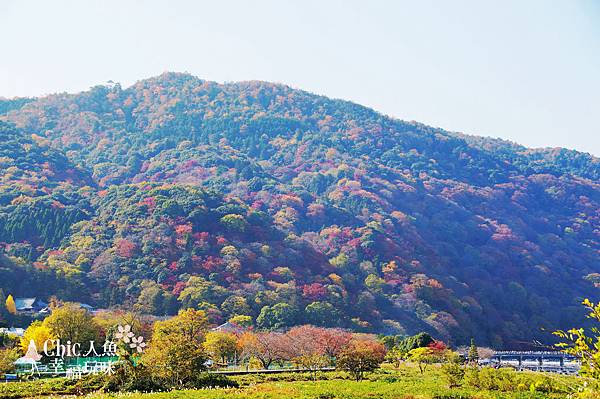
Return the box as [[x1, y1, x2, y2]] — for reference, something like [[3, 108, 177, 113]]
[[488, 351, 581, 374]]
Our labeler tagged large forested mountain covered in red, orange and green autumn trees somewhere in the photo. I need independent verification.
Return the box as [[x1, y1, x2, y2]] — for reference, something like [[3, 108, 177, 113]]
[[0, 73, 600, 347]]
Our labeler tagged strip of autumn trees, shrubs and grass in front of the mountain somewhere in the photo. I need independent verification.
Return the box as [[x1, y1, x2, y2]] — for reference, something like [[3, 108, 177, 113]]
[[0, 300, 600, 399]]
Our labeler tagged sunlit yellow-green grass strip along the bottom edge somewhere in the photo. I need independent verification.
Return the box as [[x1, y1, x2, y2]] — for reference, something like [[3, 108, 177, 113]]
[[0, 366, 581, 399]]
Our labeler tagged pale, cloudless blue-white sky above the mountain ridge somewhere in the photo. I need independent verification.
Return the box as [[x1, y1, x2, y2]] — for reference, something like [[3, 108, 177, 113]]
[[0, 0, 600, 156]]
